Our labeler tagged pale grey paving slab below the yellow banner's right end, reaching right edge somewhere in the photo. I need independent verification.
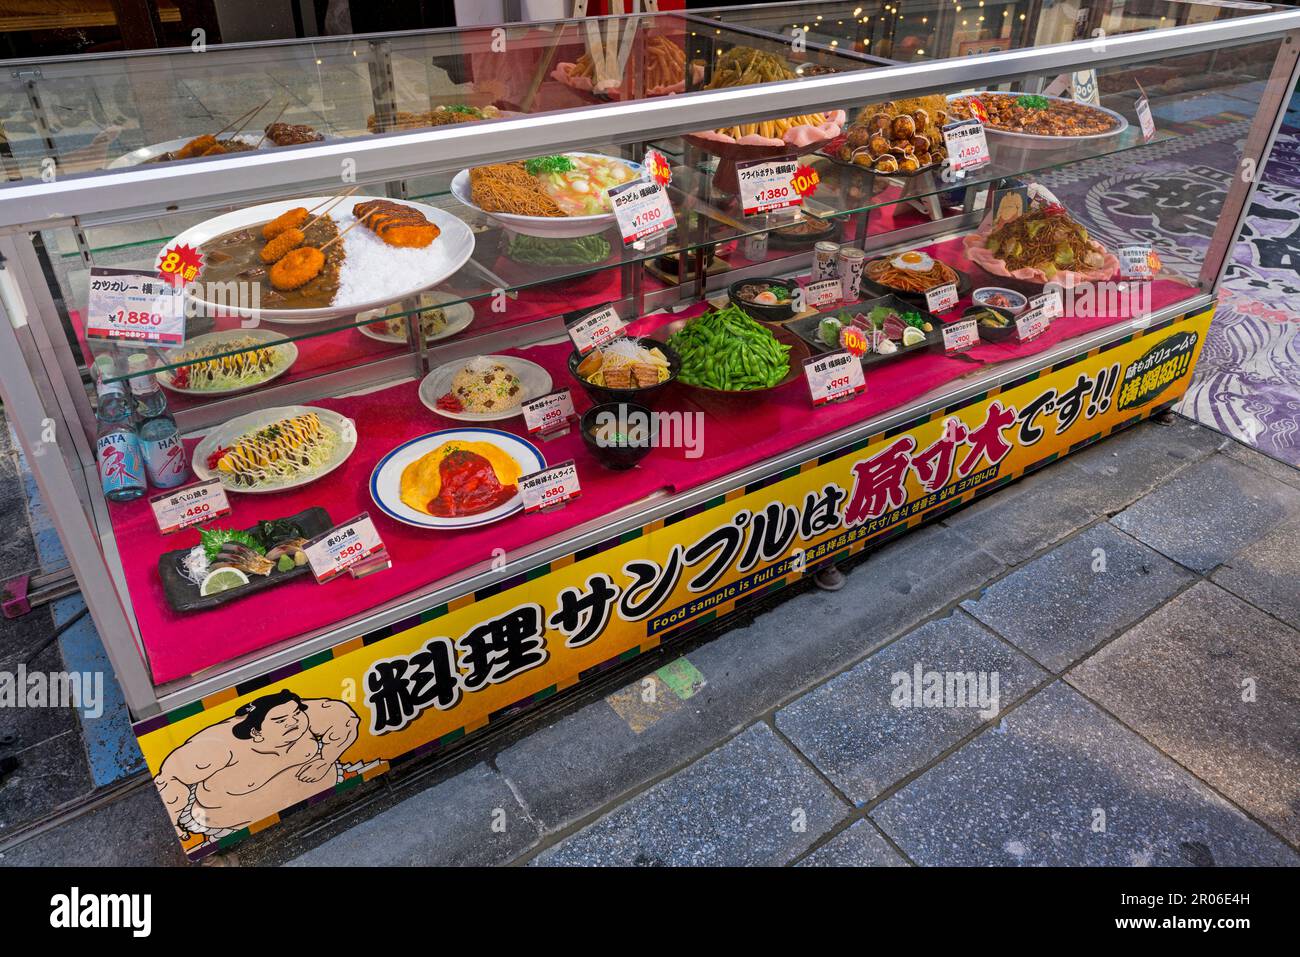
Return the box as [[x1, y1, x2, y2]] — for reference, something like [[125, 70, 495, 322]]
[[1112, 455, 1300, 575]]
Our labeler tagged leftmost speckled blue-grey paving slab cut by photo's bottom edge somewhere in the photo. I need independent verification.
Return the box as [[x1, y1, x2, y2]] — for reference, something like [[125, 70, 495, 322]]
[[534, 724, 848, 867]]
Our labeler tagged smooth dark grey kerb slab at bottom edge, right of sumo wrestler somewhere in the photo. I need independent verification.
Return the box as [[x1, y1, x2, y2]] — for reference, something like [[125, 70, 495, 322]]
[[289, 765, 540, 867]]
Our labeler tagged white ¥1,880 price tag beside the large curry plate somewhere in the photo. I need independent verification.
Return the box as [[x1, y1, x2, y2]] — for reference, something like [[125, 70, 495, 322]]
[[86, 265, 185, 346]]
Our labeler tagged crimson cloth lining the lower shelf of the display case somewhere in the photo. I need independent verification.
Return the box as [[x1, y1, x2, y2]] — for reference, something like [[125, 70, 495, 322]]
[[94, 239, 1195, 683]]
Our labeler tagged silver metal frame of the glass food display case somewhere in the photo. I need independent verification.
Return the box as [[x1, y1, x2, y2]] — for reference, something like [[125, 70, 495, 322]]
[[0, 10, 1300, 719]]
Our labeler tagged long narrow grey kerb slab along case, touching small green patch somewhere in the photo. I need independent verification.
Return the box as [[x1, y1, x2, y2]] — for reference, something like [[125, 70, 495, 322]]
[[497, 527, 1001, 830]]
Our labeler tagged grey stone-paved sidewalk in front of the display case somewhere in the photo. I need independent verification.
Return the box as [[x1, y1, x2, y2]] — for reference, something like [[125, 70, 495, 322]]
[[3, 417, 1300, 866]]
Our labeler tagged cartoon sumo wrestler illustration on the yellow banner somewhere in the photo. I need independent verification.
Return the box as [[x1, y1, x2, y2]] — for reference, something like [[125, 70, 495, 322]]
[[153, 689, 380, 843]]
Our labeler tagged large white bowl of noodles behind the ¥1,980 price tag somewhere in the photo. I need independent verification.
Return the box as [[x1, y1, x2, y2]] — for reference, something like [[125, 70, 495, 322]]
[[451, 152, 641, 239]]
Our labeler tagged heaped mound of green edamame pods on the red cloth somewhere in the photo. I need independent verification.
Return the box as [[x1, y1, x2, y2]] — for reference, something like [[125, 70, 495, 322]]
[[668, 304, 790, 391]]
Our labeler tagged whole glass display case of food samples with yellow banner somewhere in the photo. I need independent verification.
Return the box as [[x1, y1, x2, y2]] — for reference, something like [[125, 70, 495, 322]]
[[0, 0, 1300, 857]]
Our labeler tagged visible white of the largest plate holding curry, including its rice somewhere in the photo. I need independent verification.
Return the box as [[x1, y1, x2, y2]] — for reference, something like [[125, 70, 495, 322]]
[[155, 196, 475, 325]]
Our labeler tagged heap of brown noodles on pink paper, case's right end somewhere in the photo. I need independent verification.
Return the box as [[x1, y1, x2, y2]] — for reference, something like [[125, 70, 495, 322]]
[[962, 203, 1119, 289]]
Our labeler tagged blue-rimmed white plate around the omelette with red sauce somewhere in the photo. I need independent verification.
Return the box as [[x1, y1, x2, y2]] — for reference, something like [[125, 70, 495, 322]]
[[371, 429, 546, 528]]
